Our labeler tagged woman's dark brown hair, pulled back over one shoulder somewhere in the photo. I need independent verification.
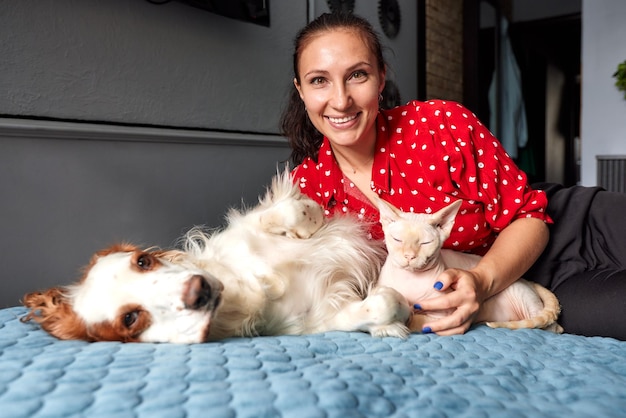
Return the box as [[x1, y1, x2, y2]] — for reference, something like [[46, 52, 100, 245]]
[[280, 13, 386, 166]]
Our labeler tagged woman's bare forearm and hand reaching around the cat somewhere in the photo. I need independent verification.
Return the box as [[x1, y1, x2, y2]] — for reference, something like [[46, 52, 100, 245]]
[[419, 218, 549, 335]]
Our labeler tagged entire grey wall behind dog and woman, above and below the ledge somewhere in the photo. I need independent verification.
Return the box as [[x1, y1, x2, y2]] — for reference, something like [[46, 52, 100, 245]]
[[0, 0, 417, 307]]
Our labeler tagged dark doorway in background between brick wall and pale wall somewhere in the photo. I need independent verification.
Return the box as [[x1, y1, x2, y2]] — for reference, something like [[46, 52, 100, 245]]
[[464, 0, 581, 185]]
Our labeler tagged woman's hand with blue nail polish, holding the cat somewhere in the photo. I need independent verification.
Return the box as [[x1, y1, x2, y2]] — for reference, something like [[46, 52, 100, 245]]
[[416, 269, 488, 335]]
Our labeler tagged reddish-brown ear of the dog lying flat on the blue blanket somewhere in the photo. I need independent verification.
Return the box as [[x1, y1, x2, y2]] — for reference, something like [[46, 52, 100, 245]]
[[21, 287, 89, 340]]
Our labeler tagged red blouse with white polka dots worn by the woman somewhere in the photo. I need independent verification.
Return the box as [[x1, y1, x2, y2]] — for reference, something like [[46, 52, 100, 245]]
[[294, 100, 552, 254]]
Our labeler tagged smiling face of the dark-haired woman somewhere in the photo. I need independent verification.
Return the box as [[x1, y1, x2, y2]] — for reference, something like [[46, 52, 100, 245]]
[[294, 30, 385, 151]]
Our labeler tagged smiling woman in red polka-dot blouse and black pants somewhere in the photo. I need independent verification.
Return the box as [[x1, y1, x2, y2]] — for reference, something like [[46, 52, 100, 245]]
[[282, 14, 626, 339]]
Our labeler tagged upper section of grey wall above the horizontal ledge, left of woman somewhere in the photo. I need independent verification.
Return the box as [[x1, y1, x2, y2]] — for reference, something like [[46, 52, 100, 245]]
[[0, 0, 307, 133]]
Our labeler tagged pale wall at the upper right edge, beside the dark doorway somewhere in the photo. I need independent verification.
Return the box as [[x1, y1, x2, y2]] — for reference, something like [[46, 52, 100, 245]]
[[581, 0, 626, 186]]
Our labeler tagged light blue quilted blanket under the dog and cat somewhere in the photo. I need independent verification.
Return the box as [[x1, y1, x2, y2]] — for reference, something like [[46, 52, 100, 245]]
[[0, 308, 626, 418]]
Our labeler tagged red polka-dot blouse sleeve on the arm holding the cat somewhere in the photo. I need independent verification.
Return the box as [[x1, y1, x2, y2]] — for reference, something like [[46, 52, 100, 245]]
[[440, 102, 551, 232]]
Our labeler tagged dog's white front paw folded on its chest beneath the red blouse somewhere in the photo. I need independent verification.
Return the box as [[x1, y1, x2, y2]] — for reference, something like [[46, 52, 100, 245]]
[[260, 197, 324, 238]]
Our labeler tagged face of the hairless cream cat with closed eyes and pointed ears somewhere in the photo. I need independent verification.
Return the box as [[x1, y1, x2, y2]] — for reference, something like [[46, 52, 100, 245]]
[[378, 199, 461, 270]]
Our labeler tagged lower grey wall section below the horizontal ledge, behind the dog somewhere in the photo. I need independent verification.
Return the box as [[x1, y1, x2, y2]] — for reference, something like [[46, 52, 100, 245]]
[[0, 119, 288, 307]]
